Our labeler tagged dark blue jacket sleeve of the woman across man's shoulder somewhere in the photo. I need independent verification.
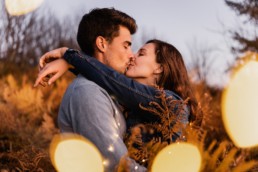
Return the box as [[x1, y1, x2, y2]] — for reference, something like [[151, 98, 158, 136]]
[[64, 49, 180, 108]]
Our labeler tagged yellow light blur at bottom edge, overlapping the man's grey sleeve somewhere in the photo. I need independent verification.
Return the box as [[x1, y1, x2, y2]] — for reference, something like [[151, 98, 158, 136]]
[[50, 133, 104, 172]]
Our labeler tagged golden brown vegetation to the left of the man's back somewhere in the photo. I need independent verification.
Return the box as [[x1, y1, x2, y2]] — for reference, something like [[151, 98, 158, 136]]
[[0, 64, 74, 172]]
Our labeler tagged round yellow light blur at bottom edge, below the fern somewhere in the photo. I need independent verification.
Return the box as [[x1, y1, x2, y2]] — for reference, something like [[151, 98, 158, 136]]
[[151, 143, 202, 172]]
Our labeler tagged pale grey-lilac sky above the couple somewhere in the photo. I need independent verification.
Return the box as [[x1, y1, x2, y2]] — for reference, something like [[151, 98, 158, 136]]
[[45, 0, 239, 86]]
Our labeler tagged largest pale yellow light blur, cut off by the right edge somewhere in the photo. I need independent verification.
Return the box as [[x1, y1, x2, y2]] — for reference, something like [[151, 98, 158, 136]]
[[222, 61, 258, 148]]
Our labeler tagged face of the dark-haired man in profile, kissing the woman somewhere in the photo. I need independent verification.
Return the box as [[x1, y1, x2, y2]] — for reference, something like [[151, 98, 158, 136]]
[[104, 26, 133, 73]]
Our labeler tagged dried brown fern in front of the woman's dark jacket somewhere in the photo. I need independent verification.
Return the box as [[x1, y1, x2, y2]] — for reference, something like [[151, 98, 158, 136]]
[[126, 88, 188, 167]]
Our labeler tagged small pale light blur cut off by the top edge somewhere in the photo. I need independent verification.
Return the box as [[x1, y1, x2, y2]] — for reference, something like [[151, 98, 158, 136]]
[[5, 0, 43, 16]]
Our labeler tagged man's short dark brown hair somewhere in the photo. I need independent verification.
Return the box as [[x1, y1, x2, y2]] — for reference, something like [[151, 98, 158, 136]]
[[77, 8, 137, 56]]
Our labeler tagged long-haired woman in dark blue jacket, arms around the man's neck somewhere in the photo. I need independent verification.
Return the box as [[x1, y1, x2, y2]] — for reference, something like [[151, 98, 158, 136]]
[[36, 40, 200, 165]]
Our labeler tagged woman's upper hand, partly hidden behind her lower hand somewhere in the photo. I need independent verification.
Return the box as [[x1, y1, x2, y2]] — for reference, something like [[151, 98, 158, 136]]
[[39, 47, 68, 70]]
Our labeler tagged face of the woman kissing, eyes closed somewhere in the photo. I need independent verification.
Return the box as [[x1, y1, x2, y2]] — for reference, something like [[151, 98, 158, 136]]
[[126, 43, 161, 85]]
